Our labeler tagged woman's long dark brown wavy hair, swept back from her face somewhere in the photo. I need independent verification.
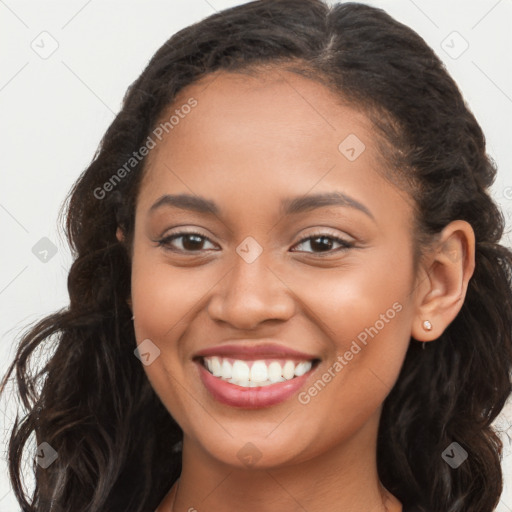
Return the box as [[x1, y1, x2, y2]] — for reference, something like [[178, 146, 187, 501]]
[[2, 0, 512, 512]]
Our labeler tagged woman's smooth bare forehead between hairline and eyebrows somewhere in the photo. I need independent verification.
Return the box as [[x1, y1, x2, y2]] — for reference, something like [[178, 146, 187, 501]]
[[139, 70, 412, 226]]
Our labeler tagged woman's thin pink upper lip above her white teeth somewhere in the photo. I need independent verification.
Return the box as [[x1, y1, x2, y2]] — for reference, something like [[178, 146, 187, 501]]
[[194, 340, 318, 361]]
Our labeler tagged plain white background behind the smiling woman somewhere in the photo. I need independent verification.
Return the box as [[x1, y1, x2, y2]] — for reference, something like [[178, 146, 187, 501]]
[[0, 0, 512, 512]]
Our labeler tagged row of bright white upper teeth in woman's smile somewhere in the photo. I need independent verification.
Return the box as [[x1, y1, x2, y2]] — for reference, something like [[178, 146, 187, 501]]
[[204, 356, 312, 388]]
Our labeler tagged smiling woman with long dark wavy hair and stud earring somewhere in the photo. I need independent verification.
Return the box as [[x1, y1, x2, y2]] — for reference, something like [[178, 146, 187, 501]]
[[2, 0, 512, 512]]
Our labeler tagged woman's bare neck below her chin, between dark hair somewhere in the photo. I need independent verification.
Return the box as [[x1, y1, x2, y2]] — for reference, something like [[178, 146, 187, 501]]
[[166, 412, 402, 512]]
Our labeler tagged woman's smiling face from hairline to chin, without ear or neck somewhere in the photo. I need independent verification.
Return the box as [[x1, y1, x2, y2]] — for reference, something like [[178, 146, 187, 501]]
[[123, 71, 415, 467]]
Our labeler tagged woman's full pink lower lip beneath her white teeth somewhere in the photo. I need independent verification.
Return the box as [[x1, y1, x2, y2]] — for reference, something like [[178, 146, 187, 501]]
[[197, 362, 314, 409]]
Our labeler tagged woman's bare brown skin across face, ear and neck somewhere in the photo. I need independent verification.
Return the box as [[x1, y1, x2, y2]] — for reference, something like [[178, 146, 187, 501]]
[[117, 70, 474, 512]]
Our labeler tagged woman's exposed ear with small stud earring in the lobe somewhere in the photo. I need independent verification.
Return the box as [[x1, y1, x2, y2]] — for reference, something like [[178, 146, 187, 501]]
[[411, 220, 475, 342]]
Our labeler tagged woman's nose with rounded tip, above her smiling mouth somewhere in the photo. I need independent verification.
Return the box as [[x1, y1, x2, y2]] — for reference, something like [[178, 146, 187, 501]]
[[208, 249, 296, 330]]
